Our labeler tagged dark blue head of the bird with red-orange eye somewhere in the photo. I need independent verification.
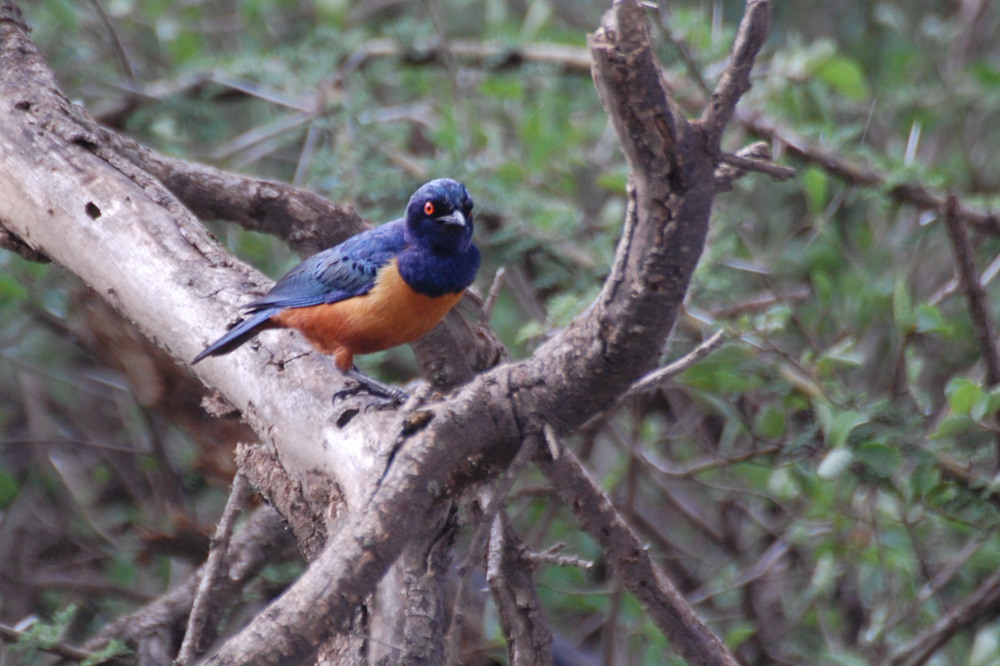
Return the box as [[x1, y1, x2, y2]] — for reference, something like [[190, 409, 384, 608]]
[[406, 178, 473, 254]]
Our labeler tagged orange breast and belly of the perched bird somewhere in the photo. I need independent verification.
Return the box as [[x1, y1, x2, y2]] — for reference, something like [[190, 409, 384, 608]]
[[271, 260, 462, 371]]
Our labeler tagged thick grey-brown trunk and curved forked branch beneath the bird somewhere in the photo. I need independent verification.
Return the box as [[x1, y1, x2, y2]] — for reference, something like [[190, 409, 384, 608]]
[[0, 0, 769, 664]]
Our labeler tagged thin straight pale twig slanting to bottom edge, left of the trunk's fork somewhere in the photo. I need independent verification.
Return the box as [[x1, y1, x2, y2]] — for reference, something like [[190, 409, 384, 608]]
[[174, 472, 250, 666]]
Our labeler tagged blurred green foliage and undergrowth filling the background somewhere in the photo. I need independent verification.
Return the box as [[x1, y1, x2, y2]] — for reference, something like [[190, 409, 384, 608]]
[[0, 0, 1000, 664]]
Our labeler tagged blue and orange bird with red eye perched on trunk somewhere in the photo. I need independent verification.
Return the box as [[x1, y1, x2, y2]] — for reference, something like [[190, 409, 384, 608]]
[[191, 178, 481, 403]]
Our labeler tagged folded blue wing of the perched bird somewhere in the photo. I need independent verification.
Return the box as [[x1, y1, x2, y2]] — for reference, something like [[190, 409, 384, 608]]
[[246, 220, 406, 312]]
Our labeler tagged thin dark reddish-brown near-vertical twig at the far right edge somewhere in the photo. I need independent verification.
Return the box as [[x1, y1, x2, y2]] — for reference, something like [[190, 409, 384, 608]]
[[944, 195, 1000, 386]]
